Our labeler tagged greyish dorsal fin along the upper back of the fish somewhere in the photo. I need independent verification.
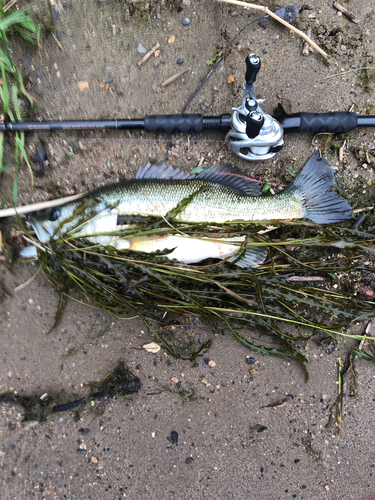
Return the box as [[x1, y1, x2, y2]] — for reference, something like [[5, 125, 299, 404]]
[[135, 162, 262, 196]]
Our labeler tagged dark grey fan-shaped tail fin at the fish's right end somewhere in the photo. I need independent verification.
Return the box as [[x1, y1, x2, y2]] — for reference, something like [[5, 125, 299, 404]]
[[286, 153, 353, 224]]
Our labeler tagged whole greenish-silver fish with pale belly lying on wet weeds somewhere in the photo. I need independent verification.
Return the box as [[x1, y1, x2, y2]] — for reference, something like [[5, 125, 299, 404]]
[[25, 153, 353, 267]]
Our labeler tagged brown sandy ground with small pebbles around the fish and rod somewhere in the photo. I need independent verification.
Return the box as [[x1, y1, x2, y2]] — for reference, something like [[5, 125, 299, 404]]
[[0, 0, 375, 500]]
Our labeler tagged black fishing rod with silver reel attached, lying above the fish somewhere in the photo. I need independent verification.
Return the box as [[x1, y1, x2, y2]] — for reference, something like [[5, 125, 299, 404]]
[[0, 54, 375, 161]]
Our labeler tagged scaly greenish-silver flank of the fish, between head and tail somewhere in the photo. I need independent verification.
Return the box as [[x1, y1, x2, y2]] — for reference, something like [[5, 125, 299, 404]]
[[96, 179, 303, 223]]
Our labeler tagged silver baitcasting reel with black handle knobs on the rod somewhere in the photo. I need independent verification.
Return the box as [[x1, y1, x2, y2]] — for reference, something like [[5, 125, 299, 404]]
[[225, 54, 284, 160]]
